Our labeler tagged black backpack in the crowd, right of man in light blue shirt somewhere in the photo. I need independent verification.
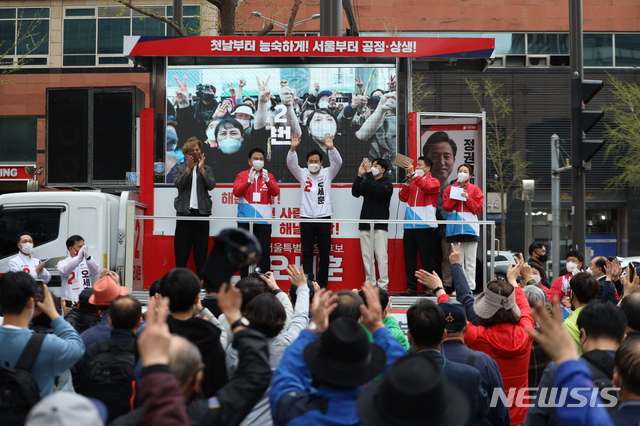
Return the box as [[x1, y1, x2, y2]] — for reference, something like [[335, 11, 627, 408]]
[[82, 338, 138, 422]]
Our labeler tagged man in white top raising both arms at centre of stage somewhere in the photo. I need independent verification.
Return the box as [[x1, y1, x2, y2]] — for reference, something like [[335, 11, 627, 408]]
[[287, 133, 342, 287]]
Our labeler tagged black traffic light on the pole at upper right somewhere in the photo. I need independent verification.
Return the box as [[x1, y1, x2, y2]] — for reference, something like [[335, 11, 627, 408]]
[[571, 78, 605, 167]]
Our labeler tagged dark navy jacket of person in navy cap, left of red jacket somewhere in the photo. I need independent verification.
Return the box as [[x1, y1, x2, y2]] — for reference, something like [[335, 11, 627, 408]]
[[442, 340, 511, 426]]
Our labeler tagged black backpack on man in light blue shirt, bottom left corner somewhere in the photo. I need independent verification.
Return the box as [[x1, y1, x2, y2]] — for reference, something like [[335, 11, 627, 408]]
[[0, 333, 46, 426]]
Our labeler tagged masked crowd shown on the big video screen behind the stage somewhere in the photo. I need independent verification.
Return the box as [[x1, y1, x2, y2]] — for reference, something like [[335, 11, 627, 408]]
[[166, 70, 396, 183]]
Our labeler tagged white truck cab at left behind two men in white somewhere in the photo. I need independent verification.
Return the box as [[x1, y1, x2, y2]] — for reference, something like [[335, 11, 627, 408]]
[[0, 191, 146, 295]]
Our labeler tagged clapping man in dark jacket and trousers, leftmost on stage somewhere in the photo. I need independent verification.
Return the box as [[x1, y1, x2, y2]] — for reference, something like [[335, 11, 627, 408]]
[[173, 138, 216, 275]]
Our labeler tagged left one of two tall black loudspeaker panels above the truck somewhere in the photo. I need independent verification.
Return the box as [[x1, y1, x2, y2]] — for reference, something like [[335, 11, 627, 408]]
[[46, 89, 89, 185]]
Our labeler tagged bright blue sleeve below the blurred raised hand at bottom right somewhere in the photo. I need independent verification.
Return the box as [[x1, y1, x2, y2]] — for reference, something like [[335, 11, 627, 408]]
[[554, 360, 613, 426]]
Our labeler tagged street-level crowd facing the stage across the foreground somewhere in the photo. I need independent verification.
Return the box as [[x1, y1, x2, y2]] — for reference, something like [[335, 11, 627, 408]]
[[0, 225, 640, 426]]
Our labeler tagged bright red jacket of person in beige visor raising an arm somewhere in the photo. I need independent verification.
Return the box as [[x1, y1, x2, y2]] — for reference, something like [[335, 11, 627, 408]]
[[438, 287, 535, 425]]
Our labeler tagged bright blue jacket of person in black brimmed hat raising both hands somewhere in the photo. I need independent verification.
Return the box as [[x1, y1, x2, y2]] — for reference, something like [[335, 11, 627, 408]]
[[269, 327, 406, 426]]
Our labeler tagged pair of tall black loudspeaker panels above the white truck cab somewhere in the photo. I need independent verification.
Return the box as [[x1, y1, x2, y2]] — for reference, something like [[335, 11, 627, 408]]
[[47, 87, 144, 187]]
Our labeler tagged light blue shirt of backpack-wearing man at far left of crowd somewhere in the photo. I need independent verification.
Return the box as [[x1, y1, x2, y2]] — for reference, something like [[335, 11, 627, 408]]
[[0, 317, 84, 398]]
